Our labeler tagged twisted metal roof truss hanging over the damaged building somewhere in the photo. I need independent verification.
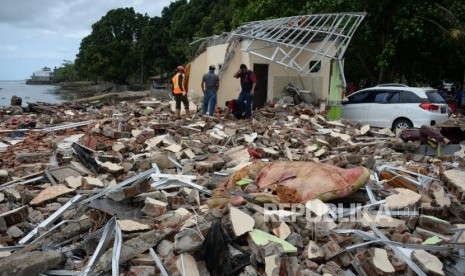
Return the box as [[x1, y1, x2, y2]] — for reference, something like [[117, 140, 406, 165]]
[[229, 13, 366, 74]]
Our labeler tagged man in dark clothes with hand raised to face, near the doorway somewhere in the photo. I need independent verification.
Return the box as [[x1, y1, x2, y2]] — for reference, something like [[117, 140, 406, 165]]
[[234, 64, 257, 119]]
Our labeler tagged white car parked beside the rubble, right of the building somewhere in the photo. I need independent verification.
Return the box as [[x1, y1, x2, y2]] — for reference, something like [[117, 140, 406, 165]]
[[341, 86, 451, 129]]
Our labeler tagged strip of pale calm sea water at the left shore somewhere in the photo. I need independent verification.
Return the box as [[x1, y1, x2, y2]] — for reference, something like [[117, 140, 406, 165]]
[[0, 80, 65, 106]]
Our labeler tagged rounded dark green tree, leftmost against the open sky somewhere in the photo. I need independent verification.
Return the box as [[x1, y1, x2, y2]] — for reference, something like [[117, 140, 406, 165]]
[[76, 8, 149, 84]]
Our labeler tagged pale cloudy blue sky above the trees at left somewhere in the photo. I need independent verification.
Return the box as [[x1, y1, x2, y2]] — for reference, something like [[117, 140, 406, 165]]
[[0, 0, 174, 80]]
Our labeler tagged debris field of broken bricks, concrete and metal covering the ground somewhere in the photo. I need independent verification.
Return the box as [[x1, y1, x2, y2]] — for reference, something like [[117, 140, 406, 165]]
[[0, 96, 465, 276]]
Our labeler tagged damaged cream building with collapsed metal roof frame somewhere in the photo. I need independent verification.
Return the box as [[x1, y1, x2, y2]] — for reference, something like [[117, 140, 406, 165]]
[[189, 13, 365, 112]]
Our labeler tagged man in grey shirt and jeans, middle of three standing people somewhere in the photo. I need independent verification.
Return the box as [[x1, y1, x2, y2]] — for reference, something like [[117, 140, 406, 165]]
[[201, 65, 220, 116]]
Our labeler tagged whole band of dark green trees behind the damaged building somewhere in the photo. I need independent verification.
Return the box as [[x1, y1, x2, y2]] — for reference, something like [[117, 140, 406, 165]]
[[71, 0, 465, 84]]
